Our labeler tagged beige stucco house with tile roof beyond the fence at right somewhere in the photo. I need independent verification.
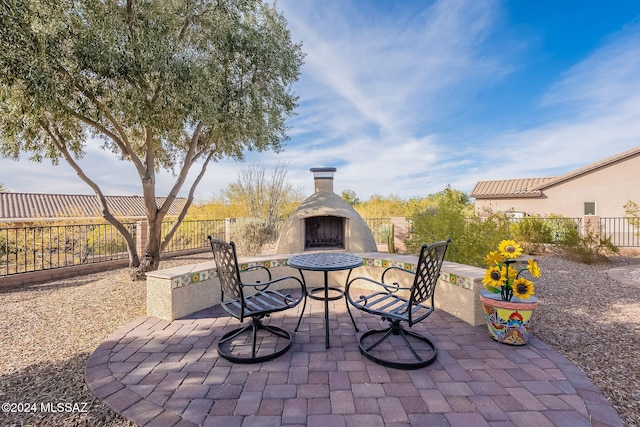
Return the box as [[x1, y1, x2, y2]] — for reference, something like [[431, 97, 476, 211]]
[[470, 146, 640, 218]]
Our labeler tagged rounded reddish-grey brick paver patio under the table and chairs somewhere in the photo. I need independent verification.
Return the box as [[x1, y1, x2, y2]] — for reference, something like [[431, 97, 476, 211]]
[[86, 299, 622, 427]]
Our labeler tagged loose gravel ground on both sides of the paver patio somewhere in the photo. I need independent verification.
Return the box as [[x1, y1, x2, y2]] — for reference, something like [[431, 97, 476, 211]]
[[0, 254, 640, 427]]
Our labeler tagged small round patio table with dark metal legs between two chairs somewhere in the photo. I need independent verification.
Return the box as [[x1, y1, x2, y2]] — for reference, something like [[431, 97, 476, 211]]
[[287, 252, 363, 348]]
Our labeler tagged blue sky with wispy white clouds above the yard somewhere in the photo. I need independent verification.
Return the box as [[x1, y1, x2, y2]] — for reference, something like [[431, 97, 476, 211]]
[[0, 0, 640, 200]]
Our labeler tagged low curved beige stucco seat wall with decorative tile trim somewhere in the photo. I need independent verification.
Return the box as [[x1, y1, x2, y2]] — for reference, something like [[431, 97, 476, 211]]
[[147, 252, 484, 326]]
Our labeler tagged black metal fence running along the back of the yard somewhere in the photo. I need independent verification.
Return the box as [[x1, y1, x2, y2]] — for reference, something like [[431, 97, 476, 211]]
[[0, 217, 640, 277]]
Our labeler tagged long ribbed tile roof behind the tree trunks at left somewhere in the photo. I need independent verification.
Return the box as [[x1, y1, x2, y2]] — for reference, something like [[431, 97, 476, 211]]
[[0, 192, 187, 223]]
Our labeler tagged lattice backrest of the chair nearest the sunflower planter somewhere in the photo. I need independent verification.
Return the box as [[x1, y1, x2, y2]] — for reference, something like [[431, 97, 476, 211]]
[[410, 239, 451, 306]]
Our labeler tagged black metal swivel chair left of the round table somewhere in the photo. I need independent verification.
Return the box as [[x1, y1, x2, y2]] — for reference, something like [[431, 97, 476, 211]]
[[208, 236, 306, 363]]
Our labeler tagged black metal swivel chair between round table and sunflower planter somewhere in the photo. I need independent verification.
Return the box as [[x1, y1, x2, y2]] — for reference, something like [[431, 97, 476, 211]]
[[345, 239, 451, 369]]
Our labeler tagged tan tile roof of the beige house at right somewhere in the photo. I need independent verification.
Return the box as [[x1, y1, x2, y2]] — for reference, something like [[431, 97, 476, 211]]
[[469, 146, 640, 199]]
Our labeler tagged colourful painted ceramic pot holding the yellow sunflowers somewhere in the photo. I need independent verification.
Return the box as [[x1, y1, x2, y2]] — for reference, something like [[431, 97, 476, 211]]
[[480, 289, 538, 345]]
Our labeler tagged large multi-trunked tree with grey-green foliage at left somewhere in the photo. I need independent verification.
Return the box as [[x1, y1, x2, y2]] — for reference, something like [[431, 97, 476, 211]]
[[0, 0, 303, 271]]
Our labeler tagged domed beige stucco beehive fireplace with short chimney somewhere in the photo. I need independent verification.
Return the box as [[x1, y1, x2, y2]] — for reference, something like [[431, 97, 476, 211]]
[[276, 168, 378, 254]]
